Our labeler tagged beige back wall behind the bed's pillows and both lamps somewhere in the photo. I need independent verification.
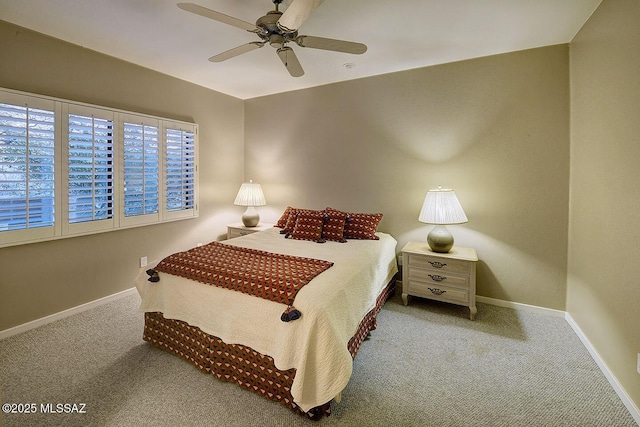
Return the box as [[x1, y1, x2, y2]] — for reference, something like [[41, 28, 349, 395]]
[[245, 45, 569, 310]]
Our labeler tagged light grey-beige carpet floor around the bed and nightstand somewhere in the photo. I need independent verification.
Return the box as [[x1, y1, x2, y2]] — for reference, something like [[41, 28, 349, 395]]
[[0, 291, 637, 427]]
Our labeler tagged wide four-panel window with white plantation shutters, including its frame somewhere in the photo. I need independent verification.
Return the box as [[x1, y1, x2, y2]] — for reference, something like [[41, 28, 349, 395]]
[[0, 88, 198, 247]]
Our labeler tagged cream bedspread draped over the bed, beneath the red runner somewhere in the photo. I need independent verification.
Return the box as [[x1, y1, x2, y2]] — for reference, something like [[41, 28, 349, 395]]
[[136, 228, 397, 411]]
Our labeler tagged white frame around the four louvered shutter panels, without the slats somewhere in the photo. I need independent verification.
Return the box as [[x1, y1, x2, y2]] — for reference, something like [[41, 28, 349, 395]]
[[0, 88, 199, 248]]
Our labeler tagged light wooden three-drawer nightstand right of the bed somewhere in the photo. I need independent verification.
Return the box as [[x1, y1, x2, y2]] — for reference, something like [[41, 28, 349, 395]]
[[402, 242, 478, 320]]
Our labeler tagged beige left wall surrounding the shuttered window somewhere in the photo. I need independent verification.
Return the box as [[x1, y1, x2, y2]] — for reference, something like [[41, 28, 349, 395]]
[[0, 21, 244, 330]]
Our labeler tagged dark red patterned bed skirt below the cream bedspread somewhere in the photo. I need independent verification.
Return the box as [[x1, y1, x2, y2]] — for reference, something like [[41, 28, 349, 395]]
[[143, 277, 395, 420]]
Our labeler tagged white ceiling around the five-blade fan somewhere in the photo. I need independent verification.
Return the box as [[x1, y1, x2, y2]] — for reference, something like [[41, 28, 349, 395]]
[[0, 0, 602, 99]]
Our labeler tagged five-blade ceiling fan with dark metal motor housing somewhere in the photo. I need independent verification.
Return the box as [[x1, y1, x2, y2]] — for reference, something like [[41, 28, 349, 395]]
[[178, 0, 367, 77]]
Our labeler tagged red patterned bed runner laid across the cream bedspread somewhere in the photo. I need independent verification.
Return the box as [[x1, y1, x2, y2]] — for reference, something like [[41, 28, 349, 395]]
[[155, 242, 333, 306]]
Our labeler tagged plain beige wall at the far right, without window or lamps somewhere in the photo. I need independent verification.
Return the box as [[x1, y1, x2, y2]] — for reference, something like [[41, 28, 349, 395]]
[[567, 0, 640, 414]]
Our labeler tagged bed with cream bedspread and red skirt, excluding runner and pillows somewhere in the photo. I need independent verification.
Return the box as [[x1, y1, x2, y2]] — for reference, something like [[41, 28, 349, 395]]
[[136, 219, 397, 418]]
